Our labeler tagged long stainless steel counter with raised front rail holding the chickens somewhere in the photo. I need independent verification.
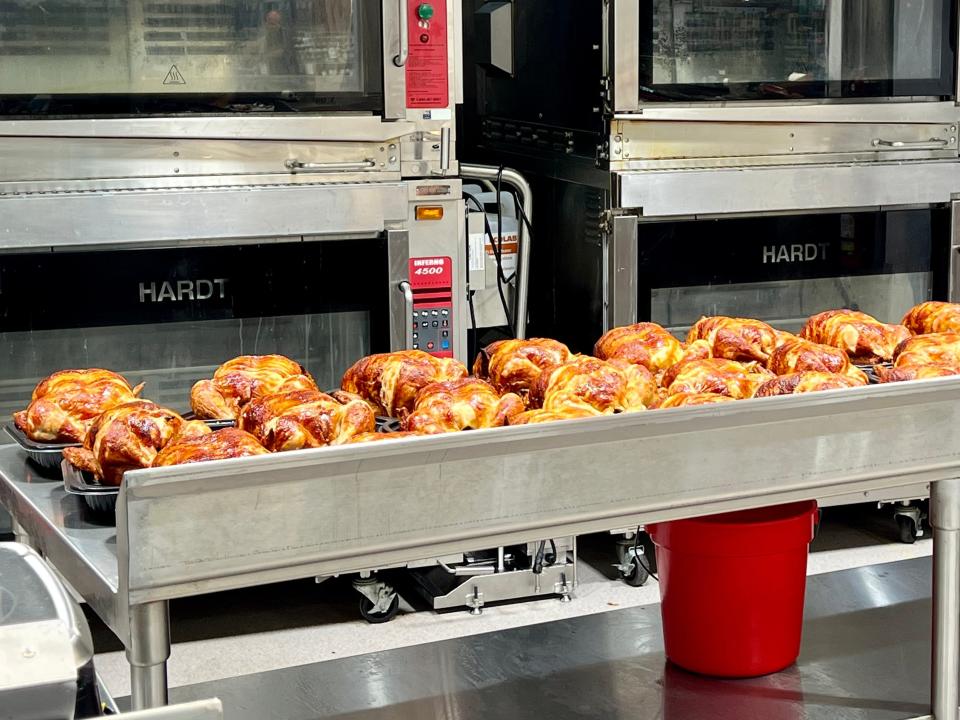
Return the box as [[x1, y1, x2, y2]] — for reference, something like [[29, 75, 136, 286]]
[[0, 378, 960, 720]]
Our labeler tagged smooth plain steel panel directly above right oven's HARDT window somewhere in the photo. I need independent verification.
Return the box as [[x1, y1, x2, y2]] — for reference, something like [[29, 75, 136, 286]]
[[614, 161, 960, 218]]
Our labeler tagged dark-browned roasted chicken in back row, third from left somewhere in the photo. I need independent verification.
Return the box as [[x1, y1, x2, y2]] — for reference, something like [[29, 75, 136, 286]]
[[340, 350, 469, 420]]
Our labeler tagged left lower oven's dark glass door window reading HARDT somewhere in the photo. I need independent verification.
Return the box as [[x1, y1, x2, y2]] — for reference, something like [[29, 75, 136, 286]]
[[0, 240, 390, 434]]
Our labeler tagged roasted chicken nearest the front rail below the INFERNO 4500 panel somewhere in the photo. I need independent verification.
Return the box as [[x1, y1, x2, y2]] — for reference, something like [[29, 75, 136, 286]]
[[403, 378, 526, 435]]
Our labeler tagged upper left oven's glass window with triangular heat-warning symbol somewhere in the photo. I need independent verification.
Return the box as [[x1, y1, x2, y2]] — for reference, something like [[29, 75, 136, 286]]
[[0, 0, 382, 116]]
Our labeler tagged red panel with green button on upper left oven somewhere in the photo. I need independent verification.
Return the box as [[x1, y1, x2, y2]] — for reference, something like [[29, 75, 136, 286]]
[[407, 0, 450, 110]]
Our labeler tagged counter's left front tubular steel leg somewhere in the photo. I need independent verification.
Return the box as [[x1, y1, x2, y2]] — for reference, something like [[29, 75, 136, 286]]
[[127, 601, 170, 710]]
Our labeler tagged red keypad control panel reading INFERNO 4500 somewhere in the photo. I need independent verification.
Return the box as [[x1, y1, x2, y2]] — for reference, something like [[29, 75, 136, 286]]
[[408, 257, 454, 357]]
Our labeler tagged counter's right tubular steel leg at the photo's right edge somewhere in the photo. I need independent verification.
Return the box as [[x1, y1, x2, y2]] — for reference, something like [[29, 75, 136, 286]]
[[930, 479, 960, 720]]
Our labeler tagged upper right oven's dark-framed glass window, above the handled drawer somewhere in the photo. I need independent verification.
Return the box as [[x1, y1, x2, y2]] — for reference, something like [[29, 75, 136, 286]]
[[640, 0, 955, 100]]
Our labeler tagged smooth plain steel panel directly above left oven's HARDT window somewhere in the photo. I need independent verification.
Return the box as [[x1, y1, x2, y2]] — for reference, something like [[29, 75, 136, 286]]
[[0, 182, 408, 250]]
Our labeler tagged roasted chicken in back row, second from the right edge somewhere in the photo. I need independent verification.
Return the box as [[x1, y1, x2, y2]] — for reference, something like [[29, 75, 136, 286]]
[[800, 310, 911, 365]]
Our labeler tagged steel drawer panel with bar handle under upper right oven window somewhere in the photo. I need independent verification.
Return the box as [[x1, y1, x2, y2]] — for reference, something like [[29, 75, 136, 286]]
[[610, 120, 958, 172]]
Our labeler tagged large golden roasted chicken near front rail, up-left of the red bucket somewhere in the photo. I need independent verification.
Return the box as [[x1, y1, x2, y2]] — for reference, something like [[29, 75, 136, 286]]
[[530, 355, 658, 415]]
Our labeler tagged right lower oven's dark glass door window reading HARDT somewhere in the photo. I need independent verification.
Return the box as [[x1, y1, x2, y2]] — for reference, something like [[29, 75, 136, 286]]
[[636, 207, 951, 337]]
